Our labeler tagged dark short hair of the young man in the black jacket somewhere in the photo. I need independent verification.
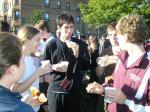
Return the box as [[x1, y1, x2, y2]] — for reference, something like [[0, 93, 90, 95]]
[[57, 14, 74, 27]]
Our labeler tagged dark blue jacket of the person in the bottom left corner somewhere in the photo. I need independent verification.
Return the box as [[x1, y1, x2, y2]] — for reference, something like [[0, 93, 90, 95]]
[[0, 85, 34, 112]]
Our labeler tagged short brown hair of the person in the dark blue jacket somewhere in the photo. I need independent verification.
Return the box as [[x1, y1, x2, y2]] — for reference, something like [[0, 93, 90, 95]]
[[0, 32, 22, 78]]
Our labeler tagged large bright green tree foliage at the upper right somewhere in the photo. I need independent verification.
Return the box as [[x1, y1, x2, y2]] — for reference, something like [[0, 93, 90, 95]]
[[80, 0, 150, 27]]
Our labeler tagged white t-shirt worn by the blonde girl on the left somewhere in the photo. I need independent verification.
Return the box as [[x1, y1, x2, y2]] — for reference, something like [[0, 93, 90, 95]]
[[20, 56, 40, 112]]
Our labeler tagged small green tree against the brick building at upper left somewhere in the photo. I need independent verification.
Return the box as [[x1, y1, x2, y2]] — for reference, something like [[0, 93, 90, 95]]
[[30, 9, 44, 24]]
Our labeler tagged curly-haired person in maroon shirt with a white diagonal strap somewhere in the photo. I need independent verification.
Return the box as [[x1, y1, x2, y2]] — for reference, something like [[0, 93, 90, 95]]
[[86, 14, 150, 112]]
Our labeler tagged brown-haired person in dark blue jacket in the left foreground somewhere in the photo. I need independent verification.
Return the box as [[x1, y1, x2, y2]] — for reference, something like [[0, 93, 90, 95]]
[[0, 33, 34, 112]]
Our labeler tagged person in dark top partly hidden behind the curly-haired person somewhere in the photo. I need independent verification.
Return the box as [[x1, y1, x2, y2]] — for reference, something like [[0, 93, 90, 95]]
[[96, 22, 119, 112]]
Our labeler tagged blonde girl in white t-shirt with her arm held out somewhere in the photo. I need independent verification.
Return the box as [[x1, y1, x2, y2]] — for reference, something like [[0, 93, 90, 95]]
[[13, 25, 51, 112]]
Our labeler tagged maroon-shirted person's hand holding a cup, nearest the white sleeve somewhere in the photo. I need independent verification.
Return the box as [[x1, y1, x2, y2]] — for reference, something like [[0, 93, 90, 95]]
[[105, 89, 126, 104]]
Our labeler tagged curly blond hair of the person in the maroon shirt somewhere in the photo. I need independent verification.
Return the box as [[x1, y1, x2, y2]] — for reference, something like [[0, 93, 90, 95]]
[[116, 14, 148, 44]]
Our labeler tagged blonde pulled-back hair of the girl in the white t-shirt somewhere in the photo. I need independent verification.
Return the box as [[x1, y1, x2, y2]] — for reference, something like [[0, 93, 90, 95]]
[[17, 25, 39, 44]]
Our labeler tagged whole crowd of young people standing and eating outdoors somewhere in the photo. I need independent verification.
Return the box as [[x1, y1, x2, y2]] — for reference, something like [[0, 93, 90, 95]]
[[0, 14, 150, 112]]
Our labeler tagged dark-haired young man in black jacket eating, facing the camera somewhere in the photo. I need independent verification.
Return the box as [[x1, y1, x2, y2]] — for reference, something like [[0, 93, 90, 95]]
[[43, 14, 90, 112]]
